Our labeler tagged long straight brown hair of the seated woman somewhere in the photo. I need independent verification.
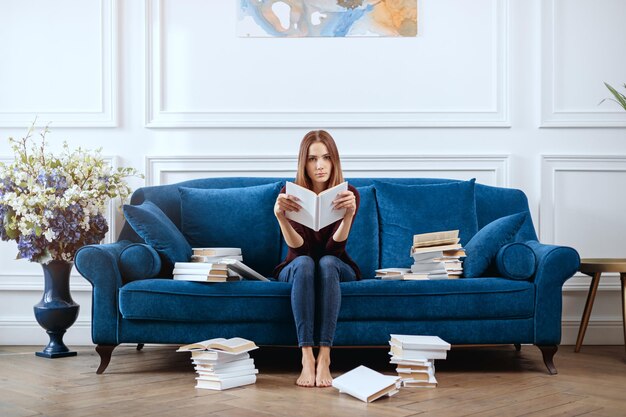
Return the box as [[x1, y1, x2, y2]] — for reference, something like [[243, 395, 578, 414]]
[[296, 130, 343, 190]]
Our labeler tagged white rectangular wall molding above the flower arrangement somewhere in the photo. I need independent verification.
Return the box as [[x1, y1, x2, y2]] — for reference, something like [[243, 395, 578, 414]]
[[0, 0, 119, 127]]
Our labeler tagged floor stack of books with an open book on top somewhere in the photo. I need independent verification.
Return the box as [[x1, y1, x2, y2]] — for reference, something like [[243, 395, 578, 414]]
[[177, 337, 259, 390]]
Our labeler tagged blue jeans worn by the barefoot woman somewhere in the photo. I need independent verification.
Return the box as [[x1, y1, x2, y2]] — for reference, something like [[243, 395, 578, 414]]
[[278, 255, 356, 347]]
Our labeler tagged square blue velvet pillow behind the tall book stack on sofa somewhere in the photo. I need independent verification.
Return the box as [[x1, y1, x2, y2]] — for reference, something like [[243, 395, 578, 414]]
[[374, 179, 478, 268]]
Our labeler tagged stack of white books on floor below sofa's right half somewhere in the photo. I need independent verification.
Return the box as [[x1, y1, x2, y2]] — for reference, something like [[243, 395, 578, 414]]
[[389, 334, 450, 388]]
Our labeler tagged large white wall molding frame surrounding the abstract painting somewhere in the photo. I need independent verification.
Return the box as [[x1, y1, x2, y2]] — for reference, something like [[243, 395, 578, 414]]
[[145, 0, 510, 128]]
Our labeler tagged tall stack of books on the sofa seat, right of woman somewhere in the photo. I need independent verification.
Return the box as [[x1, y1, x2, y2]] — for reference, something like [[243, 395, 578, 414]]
[[410, 230, 465, 279]]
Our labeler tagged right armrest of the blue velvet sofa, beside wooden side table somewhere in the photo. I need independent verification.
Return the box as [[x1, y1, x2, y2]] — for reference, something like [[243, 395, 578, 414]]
[[525, 241, 580, 345]]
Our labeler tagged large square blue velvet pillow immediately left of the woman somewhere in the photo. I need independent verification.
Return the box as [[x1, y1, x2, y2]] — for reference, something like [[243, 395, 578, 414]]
[[178, 182, 283, 276]]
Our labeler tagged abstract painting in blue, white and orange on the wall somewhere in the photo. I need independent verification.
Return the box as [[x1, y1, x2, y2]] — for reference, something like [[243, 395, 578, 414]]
[[237, 0, 417, 37]]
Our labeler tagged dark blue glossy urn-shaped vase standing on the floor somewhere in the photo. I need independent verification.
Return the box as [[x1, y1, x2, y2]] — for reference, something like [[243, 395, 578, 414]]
[[33, 261, 80, 359]]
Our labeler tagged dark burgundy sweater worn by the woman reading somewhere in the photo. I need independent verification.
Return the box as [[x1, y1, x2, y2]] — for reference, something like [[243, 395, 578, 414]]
[[274, 184, 361, 279]]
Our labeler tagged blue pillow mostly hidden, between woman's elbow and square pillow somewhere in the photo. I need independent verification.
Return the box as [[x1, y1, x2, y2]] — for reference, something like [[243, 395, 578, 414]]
[[346, 185, 379, 279]]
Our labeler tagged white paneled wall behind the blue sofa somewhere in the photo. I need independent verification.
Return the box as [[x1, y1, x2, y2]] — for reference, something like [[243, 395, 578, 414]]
[[0, 0, 626, 344]]
